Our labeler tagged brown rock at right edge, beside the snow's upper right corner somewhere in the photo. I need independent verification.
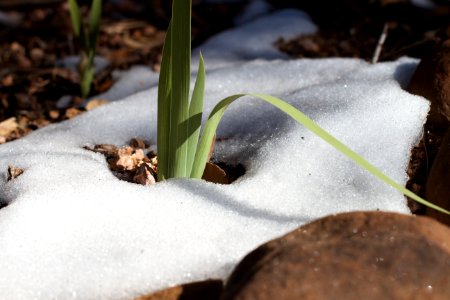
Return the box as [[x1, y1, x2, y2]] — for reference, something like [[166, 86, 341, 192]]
[[407, 39, 450, 127]]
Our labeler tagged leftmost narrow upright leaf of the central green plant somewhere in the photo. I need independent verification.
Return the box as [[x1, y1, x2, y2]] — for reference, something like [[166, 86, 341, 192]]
[[157, 24, 172, 181]]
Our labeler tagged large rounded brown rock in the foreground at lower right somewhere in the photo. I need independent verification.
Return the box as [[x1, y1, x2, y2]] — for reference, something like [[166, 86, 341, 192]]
[[221, 212, 450, 300]]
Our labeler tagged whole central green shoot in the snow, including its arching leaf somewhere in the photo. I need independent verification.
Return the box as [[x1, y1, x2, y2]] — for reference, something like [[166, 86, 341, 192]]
[[157, 0, 450, 214]]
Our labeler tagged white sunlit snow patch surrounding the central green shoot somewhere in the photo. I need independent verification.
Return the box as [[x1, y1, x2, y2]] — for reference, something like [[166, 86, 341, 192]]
[[0, 11, 429, 300]]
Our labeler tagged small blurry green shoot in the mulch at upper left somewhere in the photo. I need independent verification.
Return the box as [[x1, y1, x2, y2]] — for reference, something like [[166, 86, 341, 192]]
[[68, 0, 102, 98]]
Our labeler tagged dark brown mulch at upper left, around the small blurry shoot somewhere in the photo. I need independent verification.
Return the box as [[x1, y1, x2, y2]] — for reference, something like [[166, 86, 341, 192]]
[[0, 0, 243, 143]]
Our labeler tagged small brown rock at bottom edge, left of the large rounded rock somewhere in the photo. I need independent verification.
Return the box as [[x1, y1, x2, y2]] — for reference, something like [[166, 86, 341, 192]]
[[135, 280, 223, 300]]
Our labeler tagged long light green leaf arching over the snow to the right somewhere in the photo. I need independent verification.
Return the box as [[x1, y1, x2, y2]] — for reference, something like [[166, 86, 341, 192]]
[[192, 94, 450, 214]]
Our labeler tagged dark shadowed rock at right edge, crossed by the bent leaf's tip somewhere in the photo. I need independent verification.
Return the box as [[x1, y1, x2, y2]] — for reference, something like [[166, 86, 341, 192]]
[[425, 126, 450, 225]]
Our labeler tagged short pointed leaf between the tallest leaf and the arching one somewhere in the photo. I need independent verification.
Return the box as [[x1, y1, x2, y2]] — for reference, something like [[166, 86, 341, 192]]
[[186, 53, 206, 175]]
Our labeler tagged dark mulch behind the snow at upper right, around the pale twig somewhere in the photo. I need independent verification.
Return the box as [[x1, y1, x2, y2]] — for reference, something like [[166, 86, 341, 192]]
[[273, 0, 450, 61]]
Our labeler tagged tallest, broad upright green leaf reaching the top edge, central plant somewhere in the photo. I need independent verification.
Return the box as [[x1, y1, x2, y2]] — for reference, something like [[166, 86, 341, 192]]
[[168, 0, 192, 178]]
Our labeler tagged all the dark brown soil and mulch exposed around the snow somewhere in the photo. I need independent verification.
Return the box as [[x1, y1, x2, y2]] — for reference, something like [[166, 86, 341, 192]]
[[0, 0, 450, 218]]
